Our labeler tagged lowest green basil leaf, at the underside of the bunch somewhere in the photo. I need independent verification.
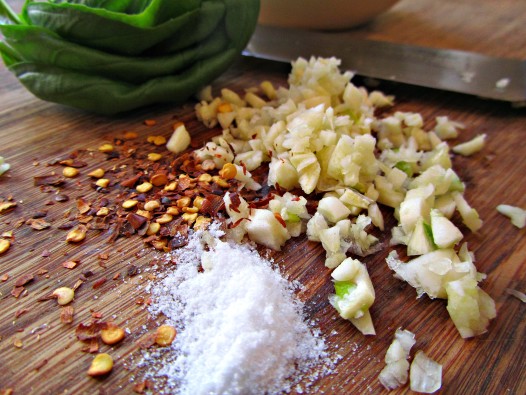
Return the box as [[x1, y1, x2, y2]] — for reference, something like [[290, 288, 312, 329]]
[[9, 48, 238, 115]]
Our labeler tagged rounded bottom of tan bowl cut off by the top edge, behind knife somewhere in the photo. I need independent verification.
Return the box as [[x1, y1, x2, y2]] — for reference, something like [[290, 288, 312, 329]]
[[259, 0, 398, 29]]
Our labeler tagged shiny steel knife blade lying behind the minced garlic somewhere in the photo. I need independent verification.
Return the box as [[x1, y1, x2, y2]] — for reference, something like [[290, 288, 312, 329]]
[[243, 25, 526, 106]]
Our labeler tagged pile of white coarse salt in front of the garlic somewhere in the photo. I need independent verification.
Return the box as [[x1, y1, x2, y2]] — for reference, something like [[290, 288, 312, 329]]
[[141, 227, 337, 395]]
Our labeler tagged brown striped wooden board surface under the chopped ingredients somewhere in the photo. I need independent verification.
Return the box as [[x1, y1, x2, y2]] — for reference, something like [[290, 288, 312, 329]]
[[0, 0, 526, 394]]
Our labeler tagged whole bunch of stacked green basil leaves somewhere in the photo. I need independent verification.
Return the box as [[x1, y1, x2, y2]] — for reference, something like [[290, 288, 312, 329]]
[[0, 0, 259, 114]]
